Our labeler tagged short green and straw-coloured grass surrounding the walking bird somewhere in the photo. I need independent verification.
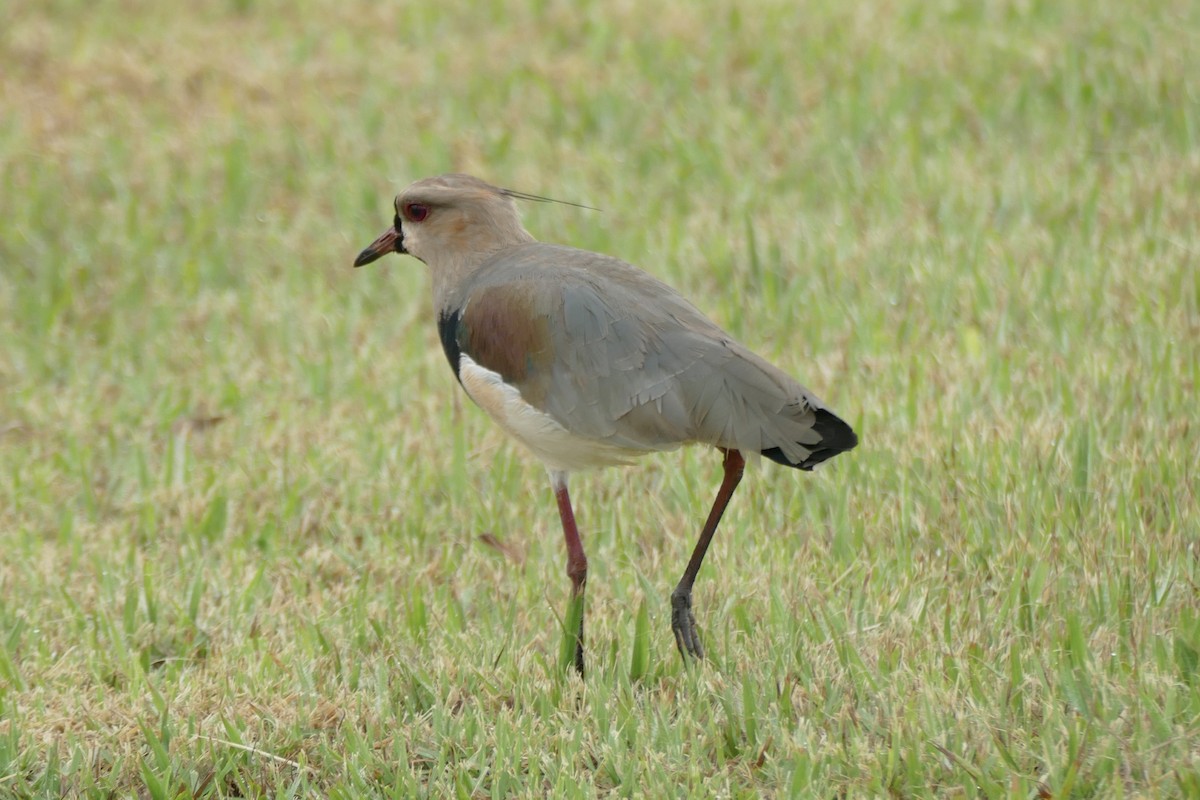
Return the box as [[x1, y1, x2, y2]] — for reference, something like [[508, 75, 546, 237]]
[[0, 0, 1200, 798]]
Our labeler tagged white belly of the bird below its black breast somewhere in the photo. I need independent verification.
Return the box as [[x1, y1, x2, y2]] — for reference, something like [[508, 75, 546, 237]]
[[458, 353, 646, 471]]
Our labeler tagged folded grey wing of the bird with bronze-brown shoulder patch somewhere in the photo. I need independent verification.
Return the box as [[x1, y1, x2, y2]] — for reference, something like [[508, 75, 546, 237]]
[[463, 243, 840, 465]]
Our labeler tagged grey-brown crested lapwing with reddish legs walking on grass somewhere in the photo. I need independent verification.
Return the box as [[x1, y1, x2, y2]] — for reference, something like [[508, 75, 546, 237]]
[[354, 173, 858, 676]]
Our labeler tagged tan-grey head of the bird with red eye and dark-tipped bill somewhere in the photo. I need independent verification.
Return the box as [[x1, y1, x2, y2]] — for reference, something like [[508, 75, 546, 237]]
[[354, 174, 533, 273]]
